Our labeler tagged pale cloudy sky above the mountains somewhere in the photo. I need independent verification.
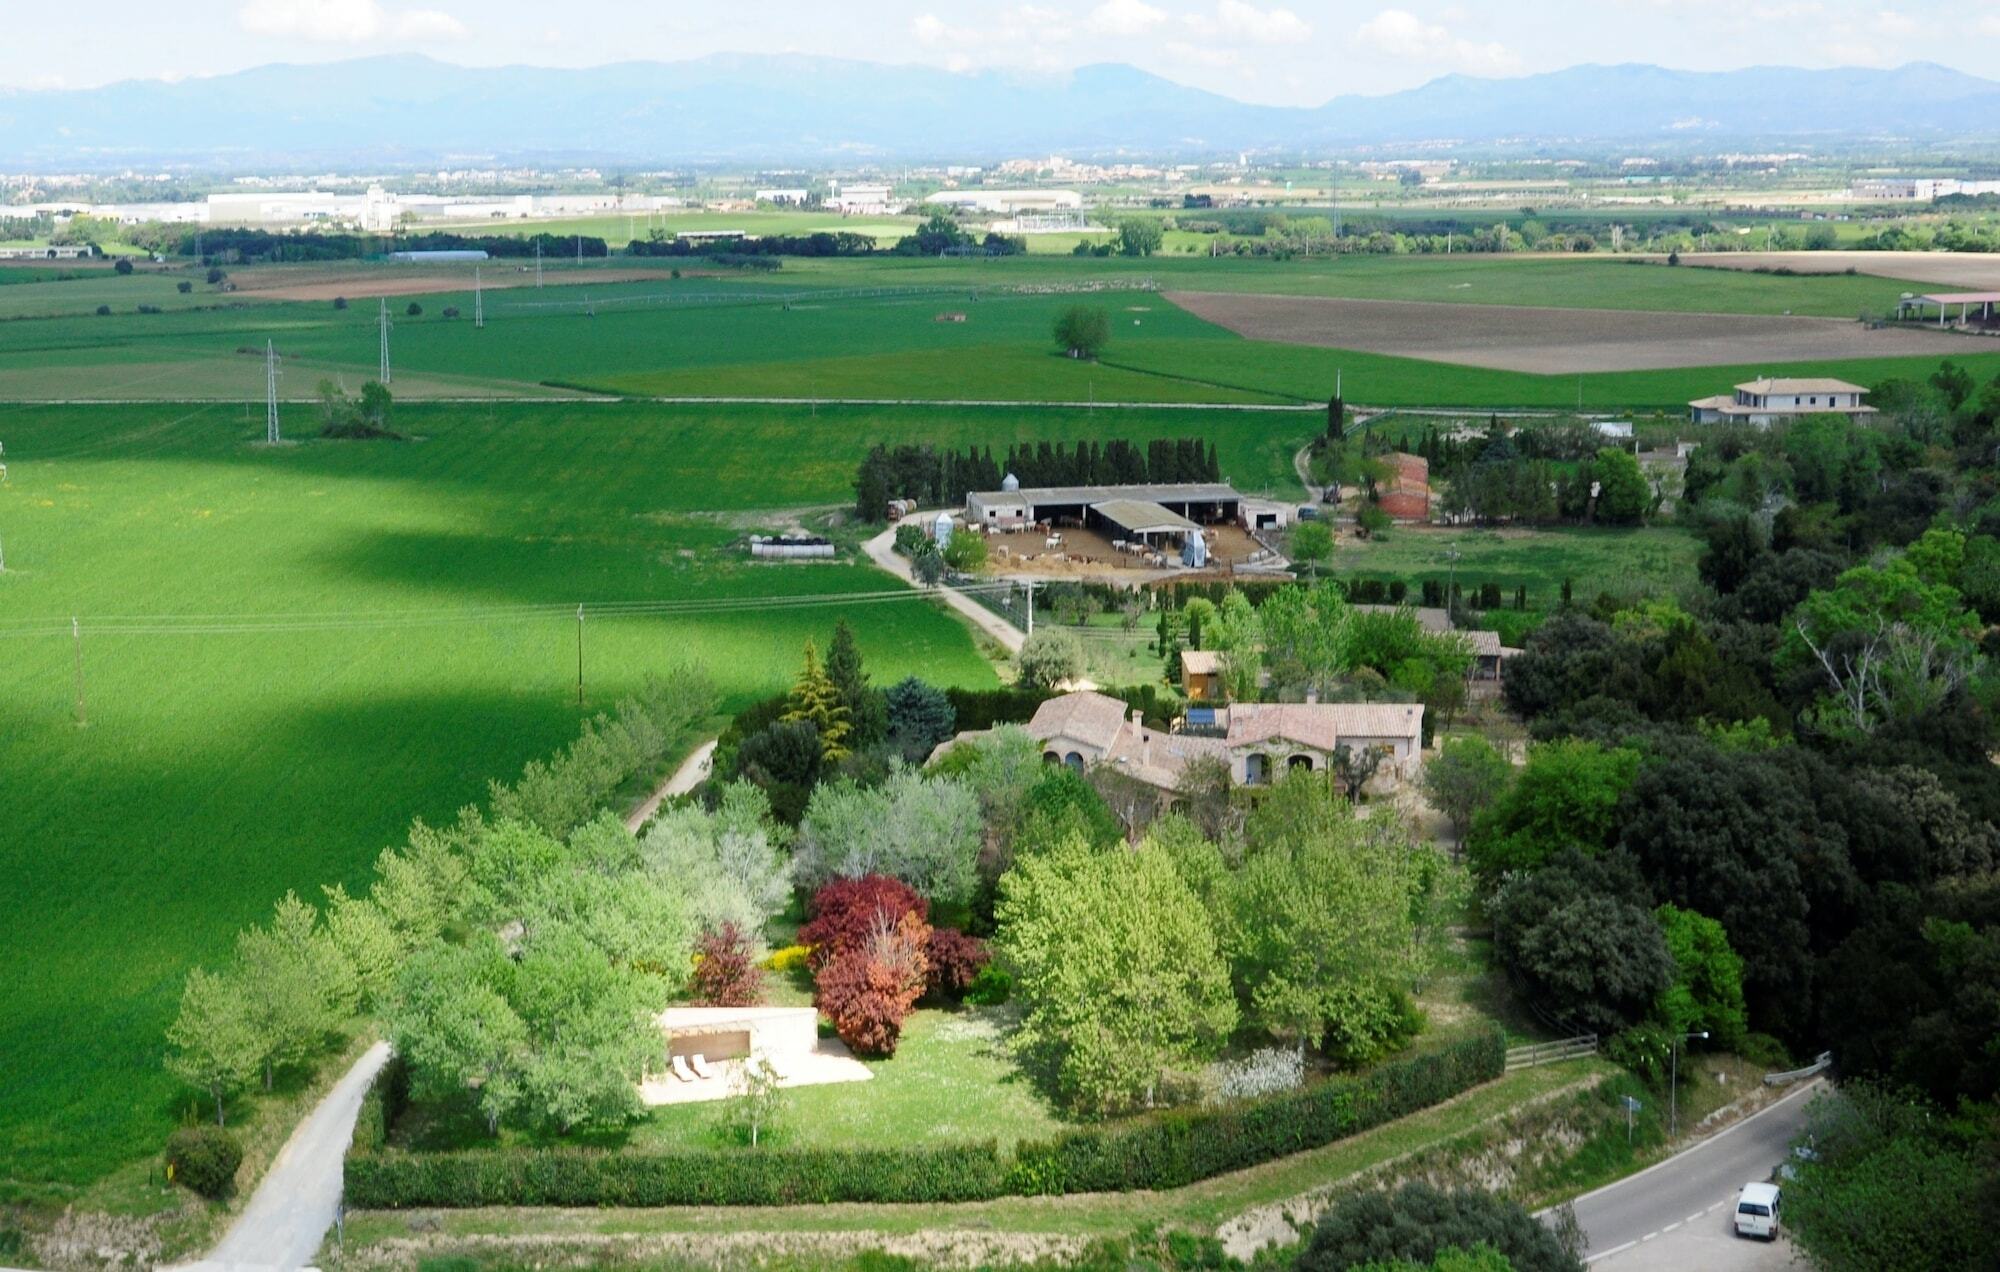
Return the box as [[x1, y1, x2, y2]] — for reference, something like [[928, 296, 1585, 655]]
[[0, 0, 2000, 106]]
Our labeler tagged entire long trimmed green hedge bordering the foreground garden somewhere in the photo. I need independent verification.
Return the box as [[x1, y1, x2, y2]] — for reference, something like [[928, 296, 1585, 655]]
[[346, 1034, 1506, 1210]]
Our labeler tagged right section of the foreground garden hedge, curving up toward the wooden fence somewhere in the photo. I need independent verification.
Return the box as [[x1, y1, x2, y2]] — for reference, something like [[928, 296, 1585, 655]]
[[1008, 1034, 1506, 1194]]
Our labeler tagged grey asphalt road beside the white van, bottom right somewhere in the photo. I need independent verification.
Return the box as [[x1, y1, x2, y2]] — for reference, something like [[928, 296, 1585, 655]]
[[1574, 1082, 1820, 1270]]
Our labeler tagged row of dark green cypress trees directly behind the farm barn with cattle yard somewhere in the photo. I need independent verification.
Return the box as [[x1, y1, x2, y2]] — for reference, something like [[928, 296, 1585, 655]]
[[854, 438, 1222, 522]]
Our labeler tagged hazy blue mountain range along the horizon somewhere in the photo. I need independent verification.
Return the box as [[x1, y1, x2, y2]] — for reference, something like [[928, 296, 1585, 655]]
[[0, 54, 2000, 168]]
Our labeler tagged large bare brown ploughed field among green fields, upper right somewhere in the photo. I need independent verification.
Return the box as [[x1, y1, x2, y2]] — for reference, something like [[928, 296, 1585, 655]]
[[1166, 292, 1976, 376]]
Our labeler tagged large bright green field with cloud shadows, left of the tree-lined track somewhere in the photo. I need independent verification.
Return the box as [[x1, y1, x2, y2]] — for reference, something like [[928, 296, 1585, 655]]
[[0, 406, 994, 1196]]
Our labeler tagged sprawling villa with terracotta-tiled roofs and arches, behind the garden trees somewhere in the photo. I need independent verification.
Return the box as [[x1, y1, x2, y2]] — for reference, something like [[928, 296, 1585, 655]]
[[934, 692, 1424, 790]]
